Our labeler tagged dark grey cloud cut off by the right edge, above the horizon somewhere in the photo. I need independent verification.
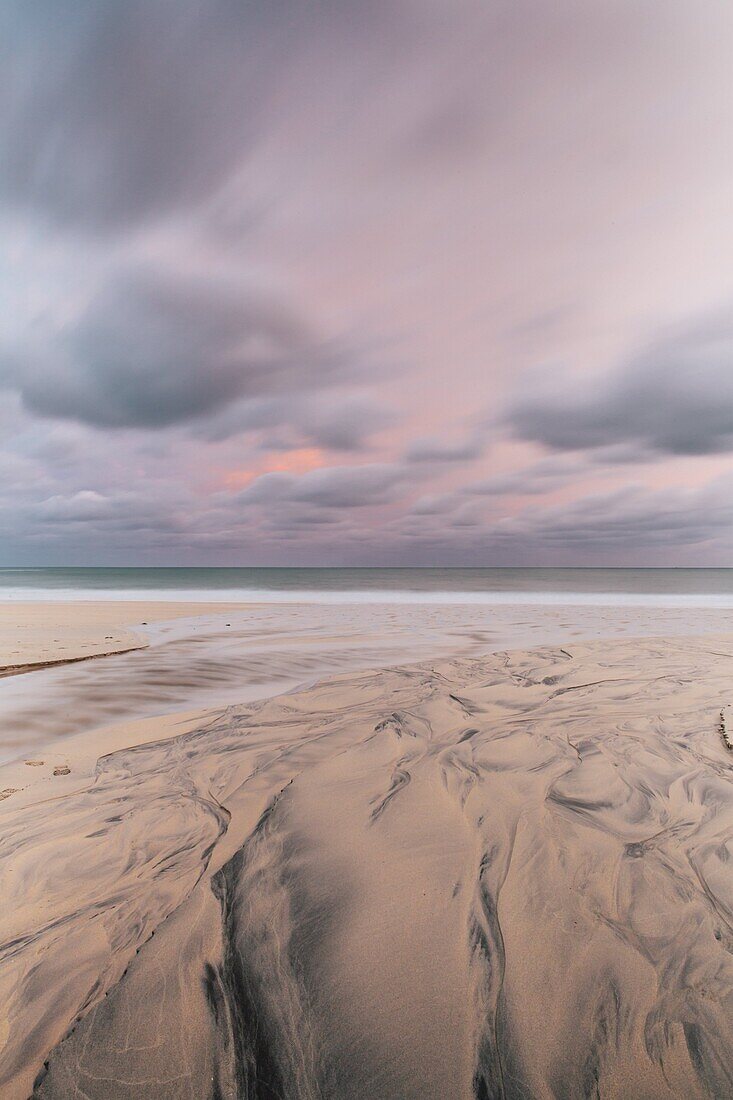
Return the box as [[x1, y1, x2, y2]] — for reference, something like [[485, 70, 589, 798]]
[[508, 322, 733, 460]]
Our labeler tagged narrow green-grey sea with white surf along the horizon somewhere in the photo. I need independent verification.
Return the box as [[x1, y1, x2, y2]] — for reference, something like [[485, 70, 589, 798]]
[[0, 568, 733, 607]]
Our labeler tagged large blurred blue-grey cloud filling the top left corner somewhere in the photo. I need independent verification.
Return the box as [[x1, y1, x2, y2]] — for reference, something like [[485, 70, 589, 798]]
[[0, 0, 283, 232]]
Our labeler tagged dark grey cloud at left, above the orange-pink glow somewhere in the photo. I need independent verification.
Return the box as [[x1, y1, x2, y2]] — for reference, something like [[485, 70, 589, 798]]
[[5, 272, 348, 428]]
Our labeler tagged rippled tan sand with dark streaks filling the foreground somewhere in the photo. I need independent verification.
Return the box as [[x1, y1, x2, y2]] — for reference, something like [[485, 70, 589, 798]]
[[0, 638, 733, 1100]]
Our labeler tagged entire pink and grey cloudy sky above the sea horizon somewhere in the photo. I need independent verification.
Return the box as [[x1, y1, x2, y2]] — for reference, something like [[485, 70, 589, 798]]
[[0, 0, 733, 565]]
